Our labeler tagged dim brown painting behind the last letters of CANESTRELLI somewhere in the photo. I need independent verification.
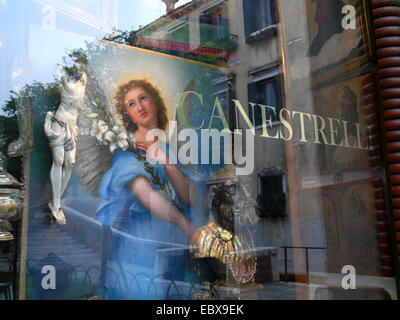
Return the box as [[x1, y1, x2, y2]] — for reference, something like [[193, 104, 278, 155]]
[[297, 73, 371, 173]]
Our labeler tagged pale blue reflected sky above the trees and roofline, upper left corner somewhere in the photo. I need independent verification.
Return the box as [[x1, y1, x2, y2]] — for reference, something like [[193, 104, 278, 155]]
[[0, 0, 190, 110]]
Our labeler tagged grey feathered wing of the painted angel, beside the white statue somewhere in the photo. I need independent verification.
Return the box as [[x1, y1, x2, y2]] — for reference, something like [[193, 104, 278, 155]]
[[75, 68, 115, 196]]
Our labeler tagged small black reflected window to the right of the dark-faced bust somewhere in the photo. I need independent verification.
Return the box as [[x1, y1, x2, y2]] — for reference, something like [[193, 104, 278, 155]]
[[257, 168, 286, 217]]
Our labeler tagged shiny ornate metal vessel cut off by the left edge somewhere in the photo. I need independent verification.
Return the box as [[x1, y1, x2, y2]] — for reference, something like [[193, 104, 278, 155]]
[[0, 152, 23, 241]]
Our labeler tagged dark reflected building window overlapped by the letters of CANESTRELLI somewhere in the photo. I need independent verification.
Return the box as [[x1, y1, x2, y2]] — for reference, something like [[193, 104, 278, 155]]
[[248, 70, 282, 128]]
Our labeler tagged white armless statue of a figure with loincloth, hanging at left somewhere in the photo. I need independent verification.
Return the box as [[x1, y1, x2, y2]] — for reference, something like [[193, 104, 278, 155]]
[[44, 56, 87, 224]]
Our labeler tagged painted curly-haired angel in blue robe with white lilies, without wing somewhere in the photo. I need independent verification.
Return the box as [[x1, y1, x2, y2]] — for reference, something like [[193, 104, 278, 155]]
[[88, 80, 196, 298]]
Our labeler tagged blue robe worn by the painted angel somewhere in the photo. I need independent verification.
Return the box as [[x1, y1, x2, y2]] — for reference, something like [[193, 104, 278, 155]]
[[97, 144, 198, 299]]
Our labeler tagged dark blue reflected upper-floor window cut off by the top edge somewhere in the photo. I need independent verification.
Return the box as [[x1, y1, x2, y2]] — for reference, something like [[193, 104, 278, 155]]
[[243, 0, 277, 36]]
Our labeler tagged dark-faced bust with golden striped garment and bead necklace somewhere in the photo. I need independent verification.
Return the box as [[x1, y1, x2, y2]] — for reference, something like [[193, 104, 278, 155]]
[[190, 165, 258, 287]]
